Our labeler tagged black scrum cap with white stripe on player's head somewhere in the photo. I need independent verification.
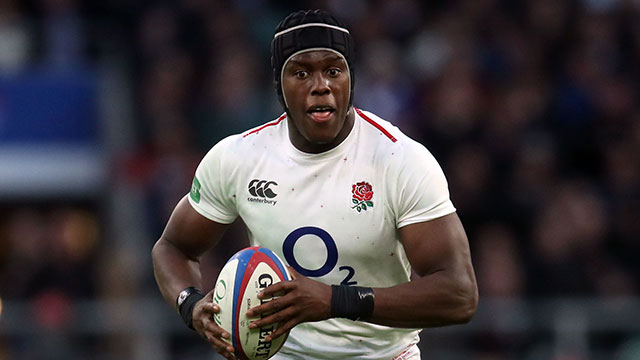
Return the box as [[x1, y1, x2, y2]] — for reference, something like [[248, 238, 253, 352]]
[[271, 10, 354, 110]]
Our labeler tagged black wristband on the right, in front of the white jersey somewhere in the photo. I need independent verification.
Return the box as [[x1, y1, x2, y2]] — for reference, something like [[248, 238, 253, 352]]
[[331, 285, 375, 320]]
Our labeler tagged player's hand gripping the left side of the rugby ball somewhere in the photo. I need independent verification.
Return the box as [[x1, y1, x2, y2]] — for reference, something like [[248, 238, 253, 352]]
[[193, 290, 235, 359]]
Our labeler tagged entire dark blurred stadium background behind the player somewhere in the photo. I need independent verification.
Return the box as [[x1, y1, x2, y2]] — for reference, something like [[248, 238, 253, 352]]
[[0, 0, 640, 360]]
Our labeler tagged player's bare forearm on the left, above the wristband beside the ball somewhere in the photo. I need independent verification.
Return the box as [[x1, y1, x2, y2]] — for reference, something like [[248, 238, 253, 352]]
[[151, 238, 202, 306]]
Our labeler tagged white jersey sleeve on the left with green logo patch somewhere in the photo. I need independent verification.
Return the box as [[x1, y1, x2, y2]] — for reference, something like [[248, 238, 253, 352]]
[[189, 137, 238, 224]]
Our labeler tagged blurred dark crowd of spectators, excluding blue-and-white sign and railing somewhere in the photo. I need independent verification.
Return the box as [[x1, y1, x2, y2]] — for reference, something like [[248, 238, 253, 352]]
[[0, 0, 640, 359]]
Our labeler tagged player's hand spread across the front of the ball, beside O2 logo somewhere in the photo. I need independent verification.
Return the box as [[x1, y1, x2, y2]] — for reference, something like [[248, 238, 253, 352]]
[[247, 267, 331, 341]]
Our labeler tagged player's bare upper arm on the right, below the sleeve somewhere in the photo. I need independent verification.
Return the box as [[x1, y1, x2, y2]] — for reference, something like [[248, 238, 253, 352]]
[[400, 213, 473, 276]]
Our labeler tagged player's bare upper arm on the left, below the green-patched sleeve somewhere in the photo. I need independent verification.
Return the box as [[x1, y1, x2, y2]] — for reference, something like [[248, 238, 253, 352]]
[[161, 196, 228, 259]]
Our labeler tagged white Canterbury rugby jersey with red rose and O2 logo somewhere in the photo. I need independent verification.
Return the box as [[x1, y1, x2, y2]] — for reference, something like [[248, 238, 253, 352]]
[[189, 109, 455, 359]]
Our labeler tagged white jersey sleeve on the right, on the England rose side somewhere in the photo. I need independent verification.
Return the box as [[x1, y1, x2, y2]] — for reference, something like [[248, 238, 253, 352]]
[[394, 141, 456, 228]]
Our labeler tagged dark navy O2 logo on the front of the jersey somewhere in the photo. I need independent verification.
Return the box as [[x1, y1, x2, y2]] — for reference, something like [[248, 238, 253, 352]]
[[282, 226, 358, 285]]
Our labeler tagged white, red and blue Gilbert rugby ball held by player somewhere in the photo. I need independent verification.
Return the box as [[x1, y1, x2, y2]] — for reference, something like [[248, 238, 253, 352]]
[[213, 246, 291, 360]]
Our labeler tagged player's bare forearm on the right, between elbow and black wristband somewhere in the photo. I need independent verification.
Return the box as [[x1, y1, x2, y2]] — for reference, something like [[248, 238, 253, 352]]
[[369, 271, 478, 328]]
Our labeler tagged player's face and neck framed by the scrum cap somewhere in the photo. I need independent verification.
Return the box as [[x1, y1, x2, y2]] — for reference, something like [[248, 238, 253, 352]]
[[282, 50, 354, 153]]
